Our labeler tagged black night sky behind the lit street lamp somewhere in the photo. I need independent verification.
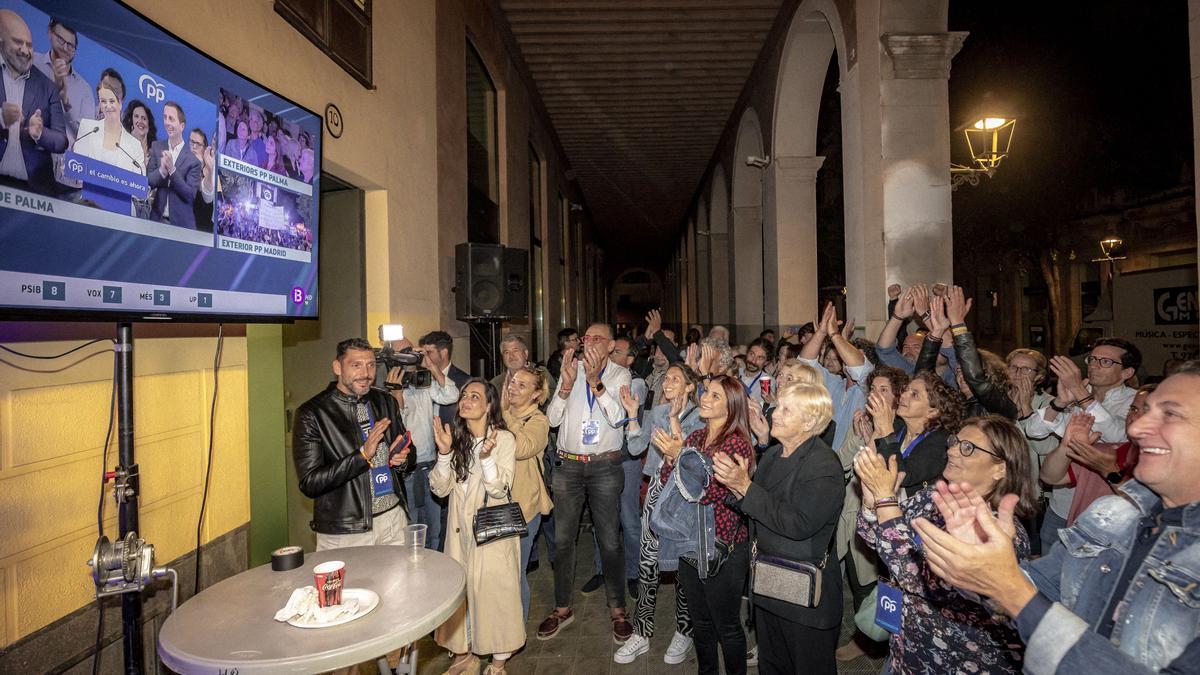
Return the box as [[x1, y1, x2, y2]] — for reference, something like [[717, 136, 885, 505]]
[[949, 0, 1193, 229]]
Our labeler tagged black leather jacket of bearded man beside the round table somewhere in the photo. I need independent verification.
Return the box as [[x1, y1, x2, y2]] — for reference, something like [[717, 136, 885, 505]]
[[292, 382, 416, 534]]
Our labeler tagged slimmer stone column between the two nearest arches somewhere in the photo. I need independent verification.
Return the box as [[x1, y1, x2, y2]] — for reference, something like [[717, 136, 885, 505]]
[[767, 156, 824, 328]]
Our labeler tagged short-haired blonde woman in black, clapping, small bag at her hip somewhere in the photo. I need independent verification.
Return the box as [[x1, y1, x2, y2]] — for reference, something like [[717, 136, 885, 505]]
[[713, 383, 846, 675]]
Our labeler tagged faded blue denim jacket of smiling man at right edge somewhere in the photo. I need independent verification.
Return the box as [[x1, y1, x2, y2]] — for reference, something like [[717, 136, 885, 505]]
[[1022, 480, 1200, 675]]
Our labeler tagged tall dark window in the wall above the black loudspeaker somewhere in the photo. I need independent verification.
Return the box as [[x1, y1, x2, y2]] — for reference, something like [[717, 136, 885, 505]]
[[467, 43, 500, 244]]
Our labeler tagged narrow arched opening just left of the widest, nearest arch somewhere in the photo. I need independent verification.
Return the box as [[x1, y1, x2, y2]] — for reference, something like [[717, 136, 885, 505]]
[[730, 108, 767, 342]]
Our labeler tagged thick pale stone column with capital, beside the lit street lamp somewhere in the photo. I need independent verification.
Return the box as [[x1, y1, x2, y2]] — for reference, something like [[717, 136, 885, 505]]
[[866, 32, 967, 297]]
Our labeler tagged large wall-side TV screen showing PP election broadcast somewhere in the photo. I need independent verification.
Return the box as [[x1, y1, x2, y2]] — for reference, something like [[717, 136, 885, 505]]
[[0, 0, 322, 322]]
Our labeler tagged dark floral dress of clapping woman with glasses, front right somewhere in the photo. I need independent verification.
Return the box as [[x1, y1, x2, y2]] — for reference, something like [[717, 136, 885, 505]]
[[858, 488, 1030, 675]]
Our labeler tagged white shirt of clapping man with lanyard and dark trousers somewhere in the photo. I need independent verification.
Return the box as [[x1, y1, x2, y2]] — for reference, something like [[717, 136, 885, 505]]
[[546, 362, 632, 455]]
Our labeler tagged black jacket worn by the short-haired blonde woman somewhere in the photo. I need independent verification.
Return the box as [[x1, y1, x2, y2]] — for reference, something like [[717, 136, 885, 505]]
[[737, 438, 846, 628]]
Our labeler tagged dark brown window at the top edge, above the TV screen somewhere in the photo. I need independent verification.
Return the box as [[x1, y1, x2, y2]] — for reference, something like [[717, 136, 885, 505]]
[[275, 0, 374, 89]]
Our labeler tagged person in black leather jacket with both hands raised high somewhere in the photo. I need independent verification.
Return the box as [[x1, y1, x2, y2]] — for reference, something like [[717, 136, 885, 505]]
[[916, 286, 1016, 419]]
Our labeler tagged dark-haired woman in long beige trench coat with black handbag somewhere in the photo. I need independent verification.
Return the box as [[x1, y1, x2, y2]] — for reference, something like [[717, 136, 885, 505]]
[[430, 380, 526, 675]]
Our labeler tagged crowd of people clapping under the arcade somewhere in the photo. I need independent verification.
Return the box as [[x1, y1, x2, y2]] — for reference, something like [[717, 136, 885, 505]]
[[294, 283, 1200, 675]]
